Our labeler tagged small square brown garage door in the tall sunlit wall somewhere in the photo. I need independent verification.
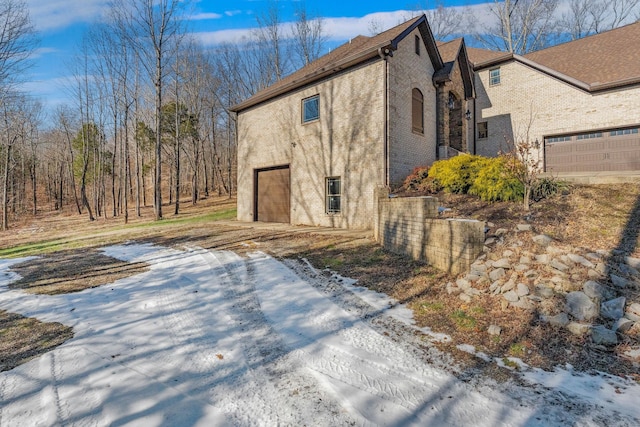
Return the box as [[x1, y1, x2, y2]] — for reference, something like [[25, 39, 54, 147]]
[[254, 165, 291, 224]]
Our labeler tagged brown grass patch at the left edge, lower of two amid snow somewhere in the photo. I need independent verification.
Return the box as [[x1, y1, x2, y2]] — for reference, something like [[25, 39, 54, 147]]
[[0, 310, 73, 371]]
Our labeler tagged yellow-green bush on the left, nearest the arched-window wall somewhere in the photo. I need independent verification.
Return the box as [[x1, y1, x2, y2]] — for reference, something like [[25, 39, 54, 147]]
[[429, 154, 490, 194]]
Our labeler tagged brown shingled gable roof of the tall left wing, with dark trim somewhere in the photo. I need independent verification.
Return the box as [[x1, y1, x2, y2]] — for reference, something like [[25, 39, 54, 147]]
[[231, 15, 443, 112]]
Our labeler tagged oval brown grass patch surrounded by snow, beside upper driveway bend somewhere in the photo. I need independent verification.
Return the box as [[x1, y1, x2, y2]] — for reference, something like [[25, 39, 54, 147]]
[[9, 249, 148, 295]]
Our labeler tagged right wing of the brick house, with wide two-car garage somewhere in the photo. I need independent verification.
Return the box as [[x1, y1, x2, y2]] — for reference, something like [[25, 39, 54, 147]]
[[468, 22, 640, 174]]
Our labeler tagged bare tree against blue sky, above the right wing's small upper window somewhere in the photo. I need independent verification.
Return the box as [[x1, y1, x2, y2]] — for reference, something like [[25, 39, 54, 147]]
[[471, 0, 557, 54]]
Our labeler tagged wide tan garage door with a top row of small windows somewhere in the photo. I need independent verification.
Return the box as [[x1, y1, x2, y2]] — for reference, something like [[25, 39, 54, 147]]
[[545, 128, 640, 173]]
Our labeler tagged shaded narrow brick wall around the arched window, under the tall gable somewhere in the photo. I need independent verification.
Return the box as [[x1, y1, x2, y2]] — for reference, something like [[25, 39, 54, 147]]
[[389, 29, 437, 187]]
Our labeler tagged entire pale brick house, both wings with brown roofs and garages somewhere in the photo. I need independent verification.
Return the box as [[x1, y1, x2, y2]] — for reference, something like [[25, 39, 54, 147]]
[[232, 15, 640, 228]]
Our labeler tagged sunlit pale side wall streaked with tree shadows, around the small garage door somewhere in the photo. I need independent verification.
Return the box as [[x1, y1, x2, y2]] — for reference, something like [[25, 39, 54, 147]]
[[237, 60, 384, 228]]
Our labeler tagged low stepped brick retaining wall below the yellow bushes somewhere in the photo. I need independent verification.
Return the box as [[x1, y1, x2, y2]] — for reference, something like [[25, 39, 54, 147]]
[[374, 189, 485, 274]]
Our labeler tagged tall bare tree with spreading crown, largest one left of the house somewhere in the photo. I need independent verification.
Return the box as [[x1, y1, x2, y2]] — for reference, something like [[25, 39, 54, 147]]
[[111, 0, 188, 220]]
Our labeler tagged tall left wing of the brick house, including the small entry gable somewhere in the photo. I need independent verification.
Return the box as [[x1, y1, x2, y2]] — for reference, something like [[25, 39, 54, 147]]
[[233, 15, 474, 228]]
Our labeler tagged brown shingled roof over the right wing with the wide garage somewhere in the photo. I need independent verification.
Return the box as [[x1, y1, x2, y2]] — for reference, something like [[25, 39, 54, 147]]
[[469, 21, 640, 92]]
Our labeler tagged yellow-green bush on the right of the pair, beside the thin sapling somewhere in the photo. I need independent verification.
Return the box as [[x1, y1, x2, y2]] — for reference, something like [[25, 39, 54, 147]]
[[468, 156, 524, 202]]
